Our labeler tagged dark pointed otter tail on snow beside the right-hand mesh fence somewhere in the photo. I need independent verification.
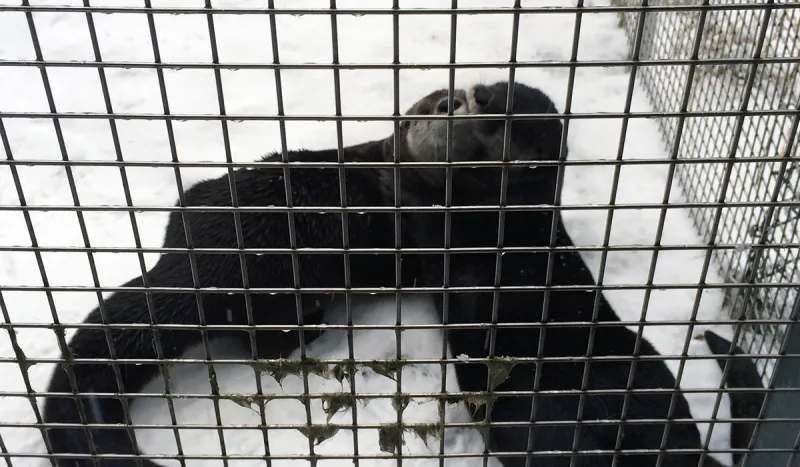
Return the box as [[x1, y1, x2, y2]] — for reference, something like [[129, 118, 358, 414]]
[[703, 331, 766, 465]]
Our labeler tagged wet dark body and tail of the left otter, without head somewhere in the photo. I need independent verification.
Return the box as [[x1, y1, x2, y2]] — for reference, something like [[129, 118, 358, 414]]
[[44, 142, 418, 467]]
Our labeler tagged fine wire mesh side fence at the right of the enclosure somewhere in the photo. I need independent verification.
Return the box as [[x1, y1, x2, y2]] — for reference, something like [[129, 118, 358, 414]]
[[616, 0, 800, 378]]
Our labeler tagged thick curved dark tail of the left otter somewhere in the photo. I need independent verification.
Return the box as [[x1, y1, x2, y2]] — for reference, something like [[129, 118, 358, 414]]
[[42, 266, 206, 467]]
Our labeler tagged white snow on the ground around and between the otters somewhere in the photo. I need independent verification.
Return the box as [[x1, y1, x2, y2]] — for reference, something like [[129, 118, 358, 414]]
[[0, 0, 744, 467]]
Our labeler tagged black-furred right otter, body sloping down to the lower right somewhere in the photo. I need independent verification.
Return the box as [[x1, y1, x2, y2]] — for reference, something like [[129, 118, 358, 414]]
[[403, 83, 764, 467]]
